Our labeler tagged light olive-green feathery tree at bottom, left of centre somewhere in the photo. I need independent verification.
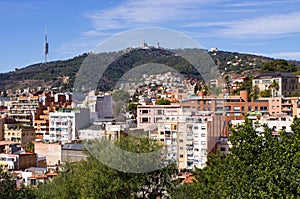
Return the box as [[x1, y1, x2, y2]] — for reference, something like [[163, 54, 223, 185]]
[[36, 137, 176, 199]]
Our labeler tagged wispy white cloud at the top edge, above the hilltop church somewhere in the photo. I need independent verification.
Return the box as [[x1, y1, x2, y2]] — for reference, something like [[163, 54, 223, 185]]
[[83, 0, 219, 35]]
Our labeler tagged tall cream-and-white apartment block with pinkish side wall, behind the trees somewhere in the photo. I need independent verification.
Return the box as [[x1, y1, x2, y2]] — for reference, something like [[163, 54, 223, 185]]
[[151, 109, 224, 170]]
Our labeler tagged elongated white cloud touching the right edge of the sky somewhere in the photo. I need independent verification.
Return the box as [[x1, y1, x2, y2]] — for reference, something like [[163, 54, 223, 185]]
[[221, 13, 300, 37]]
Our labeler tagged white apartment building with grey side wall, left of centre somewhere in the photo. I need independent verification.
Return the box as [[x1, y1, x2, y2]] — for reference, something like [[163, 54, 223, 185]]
[[44, 108, 90, 144]]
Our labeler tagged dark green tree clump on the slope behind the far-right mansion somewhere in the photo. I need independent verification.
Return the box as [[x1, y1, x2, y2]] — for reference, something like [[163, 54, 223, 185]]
[[261, 59, 297, 73]]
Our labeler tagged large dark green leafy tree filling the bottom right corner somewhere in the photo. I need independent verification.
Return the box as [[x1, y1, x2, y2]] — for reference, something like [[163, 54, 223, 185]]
[[174, 118, 300, 198]]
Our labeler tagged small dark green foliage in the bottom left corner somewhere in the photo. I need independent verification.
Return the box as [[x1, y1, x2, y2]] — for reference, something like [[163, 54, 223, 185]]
[[0, 167, 34, 199]]
